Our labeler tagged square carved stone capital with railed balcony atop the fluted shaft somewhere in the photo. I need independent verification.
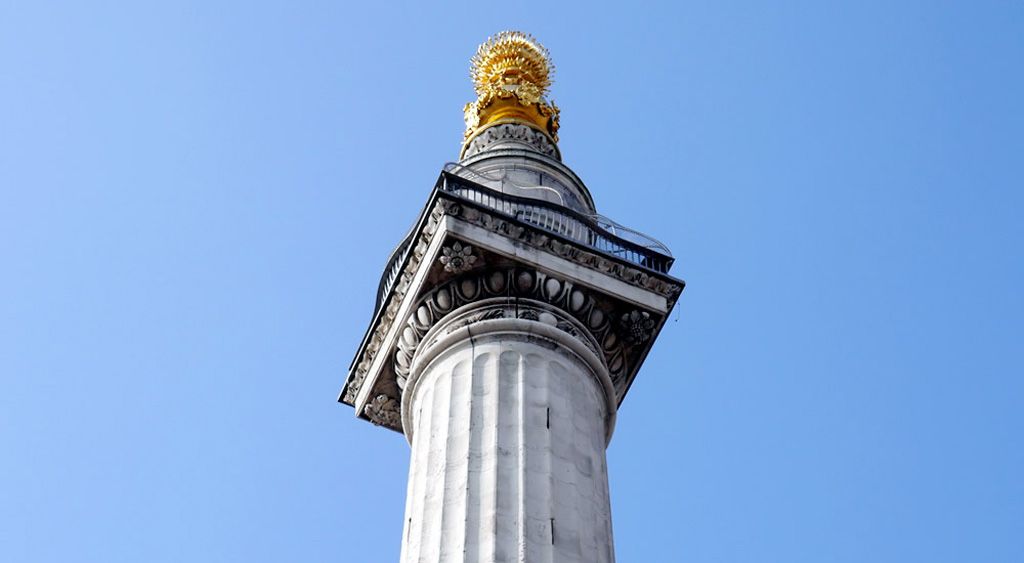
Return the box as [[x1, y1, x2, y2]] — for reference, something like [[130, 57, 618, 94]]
[[339, 173, 683, 432]]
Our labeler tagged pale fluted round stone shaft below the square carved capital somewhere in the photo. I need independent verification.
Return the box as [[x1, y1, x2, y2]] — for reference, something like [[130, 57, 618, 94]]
[[401, 299, 615, 563]]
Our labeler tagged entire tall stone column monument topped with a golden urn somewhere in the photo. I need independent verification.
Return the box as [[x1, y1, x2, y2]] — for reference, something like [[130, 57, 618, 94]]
[[339, 32, 683, 563]]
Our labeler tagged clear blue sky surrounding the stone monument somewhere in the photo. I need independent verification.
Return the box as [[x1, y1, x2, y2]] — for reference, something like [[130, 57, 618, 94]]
[[0, 0, 1024, 563]]
